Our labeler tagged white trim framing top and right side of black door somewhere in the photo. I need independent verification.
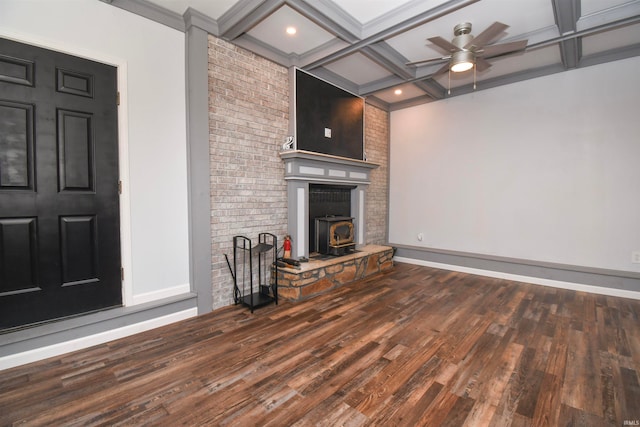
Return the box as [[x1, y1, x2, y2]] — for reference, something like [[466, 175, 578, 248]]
[[0, 30, 135, 307]]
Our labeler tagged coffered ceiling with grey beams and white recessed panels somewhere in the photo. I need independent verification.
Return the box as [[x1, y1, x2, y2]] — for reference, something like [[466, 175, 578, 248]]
[[103, 0, 640, 110]]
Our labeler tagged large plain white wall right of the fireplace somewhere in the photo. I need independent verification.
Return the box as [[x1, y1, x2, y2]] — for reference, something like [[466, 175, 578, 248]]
[[389, 58, 640, 272]]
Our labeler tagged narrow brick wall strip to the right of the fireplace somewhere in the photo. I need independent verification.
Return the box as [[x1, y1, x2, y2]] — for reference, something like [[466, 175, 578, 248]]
[[364, 104, 389, 245]]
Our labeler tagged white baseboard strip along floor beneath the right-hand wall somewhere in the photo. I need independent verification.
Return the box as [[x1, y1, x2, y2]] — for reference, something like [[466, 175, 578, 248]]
[[394, 257, 640, 299]]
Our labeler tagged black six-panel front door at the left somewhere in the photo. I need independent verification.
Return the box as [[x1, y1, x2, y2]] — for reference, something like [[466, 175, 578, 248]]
[[0, 39, 122, 330]]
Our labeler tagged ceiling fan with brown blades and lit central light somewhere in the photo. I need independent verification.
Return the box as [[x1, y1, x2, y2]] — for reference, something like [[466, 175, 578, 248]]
[[407, 22, 528, 74]]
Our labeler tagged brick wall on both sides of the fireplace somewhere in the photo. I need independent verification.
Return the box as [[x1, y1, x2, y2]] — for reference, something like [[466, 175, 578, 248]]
[[209, 36, 389, 309]]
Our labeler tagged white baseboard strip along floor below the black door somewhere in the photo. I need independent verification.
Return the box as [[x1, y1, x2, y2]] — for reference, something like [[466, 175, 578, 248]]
[[0, 307, 198, 371]]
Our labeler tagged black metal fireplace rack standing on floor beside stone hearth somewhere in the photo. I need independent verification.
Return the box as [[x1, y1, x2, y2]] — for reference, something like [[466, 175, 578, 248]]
[[233, 233, 278, 313]]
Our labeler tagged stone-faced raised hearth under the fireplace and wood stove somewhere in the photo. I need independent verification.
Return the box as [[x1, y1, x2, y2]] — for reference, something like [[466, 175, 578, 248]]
[[278, 245, 393, 301]]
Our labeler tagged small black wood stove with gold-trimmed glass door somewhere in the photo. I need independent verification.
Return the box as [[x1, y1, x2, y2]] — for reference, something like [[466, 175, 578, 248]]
[[315, 216, 356, 256]]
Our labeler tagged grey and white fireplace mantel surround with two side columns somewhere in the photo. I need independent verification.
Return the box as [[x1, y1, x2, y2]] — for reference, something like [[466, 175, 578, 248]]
[[280, 150, 379, 259]]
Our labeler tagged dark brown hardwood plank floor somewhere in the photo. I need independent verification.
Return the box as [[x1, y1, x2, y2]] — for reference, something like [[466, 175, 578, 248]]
[[0, 264, 640, 426]]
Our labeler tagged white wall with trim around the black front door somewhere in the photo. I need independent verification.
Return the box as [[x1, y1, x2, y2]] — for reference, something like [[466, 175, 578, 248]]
[[0, 0, 189, 305]]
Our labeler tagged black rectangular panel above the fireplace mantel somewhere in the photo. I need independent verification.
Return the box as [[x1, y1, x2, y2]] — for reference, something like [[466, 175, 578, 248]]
[[290, 67, 364, 160]]
